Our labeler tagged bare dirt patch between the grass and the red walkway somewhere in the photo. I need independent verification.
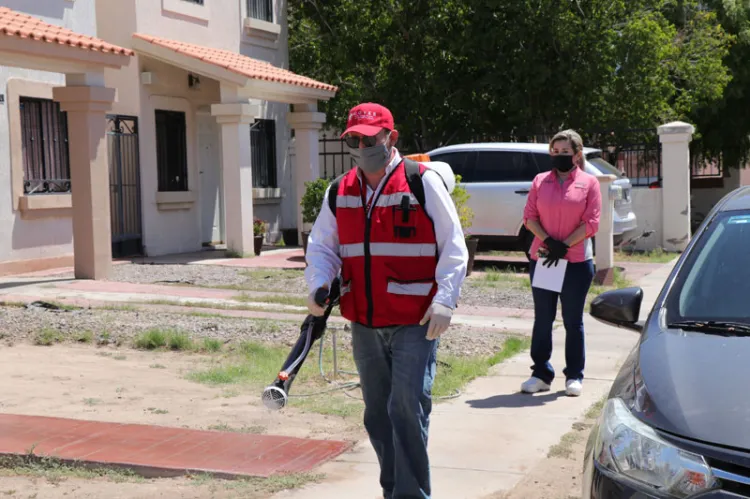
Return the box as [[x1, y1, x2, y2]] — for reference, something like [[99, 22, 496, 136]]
[[0, 344, 363, 440]]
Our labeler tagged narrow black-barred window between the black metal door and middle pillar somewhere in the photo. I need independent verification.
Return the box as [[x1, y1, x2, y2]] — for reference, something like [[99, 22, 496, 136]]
[[156, 110, 188, 192]]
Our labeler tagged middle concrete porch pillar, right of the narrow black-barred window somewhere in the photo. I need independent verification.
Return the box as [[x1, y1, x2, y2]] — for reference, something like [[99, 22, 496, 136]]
[[211, 101, 260, 257]]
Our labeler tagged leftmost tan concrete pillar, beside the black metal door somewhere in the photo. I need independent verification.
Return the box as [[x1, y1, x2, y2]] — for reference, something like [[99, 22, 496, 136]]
[[52, 74, 115, 279]]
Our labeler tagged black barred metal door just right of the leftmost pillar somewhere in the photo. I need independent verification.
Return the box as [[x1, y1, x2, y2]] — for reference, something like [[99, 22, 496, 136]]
[[107, 115, 143, 258]]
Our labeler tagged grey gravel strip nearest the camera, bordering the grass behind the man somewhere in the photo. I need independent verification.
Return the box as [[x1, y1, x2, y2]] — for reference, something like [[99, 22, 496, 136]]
[[0, 307, 520, 356]]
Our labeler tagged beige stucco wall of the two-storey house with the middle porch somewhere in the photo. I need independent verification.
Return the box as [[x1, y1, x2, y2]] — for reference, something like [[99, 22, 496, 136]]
[[98, 0, 297, 255]]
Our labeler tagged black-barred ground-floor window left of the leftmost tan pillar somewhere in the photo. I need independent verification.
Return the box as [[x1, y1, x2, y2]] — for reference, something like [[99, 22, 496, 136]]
[[19, 97, 70, 194]]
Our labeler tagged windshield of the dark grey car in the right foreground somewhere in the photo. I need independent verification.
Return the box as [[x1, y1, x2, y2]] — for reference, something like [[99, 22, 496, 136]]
[[667, 210, 750, 324]]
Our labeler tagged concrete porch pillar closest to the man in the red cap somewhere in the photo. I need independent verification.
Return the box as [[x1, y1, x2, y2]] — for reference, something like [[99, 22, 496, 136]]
[[287, 104, 326, 244]]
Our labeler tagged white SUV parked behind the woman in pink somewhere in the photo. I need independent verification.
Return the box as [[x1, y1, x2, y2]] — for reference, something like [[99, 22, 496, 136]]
[[427, 143, 638, 255]]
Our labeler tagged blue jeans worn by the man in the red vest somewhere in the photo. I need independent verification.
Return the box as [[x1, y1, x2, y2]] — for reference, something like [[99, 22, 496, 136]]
[[352, 323, 438, 499]]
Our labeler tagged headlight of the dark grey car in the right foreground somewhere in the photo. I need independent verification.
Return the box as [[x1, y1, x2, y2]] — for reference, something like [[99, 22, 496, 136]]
[[594, 398, 718, 498]]
